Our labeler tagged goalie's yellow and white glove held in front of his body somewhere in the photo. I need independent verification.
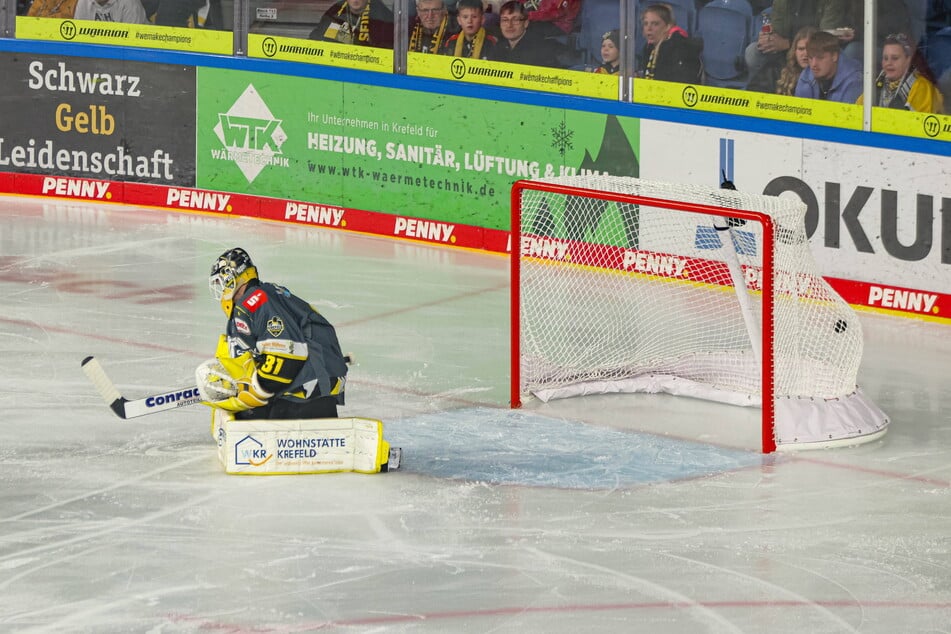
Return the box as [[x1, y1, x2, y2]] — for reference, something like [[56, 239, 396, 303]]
[[195, 352, 274, 412]]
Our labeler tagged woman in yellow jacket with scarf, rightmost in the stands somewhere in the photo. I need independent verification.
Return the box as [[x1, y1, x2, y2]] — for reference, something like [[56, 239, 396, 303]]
[[858, 33, 944, 114]]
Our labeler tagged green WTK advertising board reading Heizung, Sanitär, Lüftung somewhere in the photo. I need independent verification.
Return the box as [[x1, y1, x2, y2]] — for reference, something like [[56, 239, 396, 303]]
[[197, 68, 639, 229]]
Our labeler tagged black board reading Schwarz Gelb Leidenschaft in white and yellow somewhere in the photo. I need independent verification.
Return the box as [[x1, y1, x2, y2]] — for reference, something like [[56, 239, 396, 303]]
[[0, 53, 196, 186]]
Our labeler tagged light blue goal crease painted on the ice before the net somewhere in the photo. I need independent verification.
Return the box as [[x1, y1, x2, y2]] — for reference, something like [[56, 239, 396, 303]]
[[387, 407, 761, 489]]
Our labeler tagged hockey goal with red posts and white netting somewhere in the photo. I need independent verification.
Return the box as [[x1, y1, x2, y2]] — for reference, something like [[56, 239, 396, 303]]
[[511, 175, 888, 453]]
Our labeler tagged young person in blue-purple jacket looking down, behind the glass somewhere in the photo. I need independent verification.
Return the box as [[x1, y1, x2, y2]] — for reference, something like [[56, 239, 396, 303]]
[[796, 31, 862, 103]]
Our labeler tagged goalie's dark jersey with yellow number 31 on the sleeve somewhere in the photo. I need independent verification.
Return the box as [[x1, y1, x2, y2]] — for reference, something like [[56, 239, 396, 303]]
[[226, 279, 347, 405]]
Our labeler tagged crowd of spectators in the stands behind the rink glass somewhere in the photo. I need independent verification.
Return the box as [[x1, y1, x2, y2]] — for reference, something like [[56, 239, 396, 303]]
[[18, 0, 951, 113]]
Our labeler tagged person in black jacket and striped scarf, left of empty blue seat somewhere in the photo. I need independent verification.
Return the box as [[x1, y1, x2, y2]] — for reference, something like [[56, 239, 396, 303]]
[[637, 4, 703, 84]]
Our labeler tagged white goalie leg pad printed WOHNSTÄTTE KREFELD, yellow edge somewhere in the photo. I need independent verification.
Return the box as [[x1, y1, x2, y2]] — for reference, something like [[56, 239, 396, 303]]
[[213, 410, 398, 475]]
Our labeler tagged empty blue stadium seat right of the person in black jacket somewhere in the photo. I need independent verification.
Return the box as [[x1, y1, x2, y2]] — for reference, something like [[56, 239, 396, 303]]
[[697, 0, 753, 88]]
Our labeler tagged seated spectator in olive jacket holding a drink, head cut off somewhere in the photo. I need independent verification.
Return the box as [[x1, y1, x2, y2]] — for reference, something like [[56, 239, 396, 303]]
[[745, 0, 849, 92]]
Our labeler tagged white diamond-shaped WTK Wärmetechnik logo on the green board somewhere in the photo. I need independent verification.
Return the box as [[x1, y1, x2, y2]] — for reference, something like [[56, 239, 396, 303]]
[[212, 84, 289, 184]]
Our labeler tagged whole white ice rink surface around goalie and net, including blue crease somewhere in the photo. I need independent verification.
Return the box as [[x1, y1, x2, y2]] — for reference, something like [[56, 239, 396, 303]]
[[0, 197, 951, 634]]
